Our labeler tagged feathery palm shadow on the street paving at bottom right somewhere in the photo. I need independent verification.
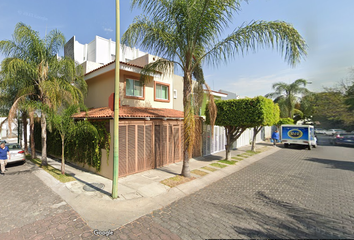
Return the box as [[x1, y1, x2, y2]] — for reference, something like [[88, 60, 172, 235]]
[[224, 191, 352, 239]]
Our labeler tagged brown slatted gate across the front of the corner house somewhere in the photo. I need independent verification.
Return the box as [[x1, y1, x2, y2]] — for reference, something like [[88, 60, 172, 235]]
[[119, 120, 183, 177]]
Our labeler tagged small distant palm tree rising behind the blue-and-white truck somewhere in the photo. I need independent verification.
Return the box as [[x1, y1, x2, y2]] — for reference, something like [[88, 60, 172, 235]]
[[266, 79, 309, 118]]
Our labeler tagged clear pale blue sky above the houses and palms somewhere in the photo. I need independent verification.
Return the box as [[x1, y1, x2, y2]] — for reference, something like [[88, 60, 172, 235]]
[[0, 0, 354, 97]]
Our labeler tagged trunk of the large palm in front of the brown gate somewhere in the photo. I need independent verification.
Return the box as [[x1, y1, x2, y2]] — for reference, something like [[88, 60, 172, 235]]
[[181, 72, 195, 178]]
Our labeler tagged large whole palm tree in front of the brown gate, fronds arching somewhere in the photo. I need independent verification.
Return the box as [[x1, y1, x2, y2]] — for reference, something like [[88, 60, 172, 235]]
[[122, 0, 306, 177]]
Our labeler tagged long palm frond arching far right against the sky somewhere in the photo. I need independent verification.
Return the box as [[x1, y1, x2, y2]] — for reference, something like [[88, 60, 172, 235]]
[[204, 21, 307, 66]]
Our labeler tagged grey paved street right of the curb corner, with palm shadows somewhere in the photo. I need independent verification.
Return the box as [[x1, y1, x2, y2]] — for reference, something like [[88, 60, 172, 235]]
[[115, 138, 354, 239]]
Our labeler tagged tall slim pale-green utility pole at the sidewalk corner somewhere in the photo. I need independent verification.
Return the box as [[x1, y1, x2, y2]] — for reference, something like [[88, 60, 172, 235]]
[[112, 0, 120, 199]]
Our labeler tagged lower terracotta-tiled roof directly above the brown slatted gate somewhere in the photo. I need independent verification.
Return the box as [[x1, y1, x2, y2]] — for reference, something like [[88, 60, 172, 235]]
[[73, 106, 184, 118]]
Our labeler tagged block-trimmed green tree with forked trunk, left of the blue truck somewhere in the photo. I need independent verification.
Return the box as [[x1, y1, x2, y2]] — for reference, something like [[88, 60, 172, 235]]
[[206, 97, 279, 159]]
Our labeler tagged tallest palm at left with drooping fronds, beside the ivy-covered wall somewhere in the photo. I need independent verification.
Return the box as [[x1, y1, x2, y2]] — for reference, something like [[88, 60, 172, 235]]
[[0, 23, 87, 166]]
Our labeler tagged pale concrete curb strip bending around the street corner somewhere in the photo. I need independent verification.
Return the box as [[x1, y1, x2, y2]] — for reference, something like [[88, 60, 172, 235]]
[[34, 144, 280, 230]]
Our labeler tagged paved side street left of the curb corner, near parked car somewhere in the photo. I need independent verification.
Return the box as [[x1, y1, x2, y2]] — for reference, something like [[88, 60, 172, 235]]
[[0, 163, 92, 240]]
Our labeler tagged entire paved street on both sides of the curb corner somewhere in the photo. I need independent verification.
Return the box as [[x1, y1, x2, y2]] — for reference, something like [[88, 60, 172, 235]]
[[0, 136, 354, 239]]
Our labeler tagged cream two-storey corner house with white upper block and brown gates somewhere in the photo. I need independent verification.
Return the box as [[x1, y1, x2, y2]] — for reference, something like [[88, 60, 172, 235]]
[[66, 37, 188, 179]]
